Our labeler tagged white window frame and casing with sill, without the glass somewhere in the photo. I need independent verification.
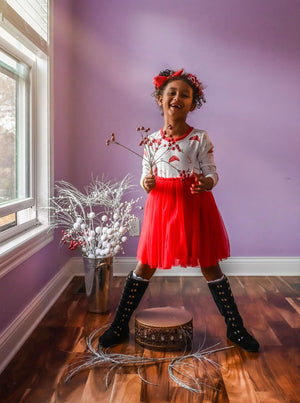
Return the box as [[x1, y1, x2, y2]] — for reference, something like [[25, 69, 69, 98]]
[[0, 1, 54, 278]]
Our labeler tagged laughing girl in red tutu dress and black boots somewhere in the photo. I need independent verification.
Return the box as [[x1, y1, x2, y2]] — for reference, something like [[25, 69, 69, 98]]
[[99, 70, 259, 351]]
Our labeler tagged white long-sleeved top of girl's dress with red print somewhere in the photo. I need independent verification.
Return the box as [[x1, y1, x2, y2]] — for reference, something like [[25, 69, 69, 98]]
[[141, 128, 218, 186]]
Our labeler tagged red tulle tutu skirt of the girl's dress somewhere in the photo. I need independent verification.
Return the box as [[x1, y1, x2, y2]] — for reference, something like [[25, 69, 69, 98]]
[[137, 177, 230, 269]]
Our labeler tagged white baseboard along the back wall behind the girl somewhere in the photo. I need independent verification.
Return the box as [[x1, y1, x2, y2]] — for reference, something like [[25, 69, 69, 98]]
[[72, 257, 300, 277]]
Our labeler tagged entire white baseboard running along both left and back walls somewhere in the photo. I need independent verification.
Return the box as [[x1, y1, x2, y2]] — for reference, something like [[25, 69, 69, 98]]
[[0, 257, 300, 373]]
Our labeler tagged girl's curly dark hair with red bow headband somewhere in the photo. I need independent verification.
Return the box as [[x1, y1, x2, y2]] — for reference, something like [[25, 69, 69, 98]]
[[152, 69, 206, 109]]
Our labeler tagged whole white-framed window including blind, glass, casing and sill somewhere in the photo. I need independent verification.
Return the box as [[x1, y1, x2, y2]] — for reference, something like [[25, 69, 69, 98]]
[[0, 0, 52, 276]]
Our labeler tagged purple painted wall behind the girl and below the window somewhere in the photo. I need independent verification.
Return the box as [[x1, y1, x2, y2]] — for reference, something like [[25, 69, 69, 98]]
[[0, 0, 300, 333]]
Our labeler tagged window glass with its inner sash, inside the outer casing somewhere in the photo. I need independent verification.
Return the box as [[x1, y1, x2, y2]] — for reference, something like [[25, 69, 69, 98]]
[[0, 49, 34, 234]]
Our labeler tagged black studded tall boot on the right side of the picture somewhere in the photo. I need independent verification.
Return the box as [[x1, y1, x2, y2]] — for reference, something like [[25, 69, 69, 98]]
[[208, 275, 259, 352]]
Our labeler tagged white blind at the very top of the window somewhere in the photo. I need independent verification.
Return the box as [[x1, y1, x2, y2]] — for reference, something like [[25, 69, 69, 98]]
[[0, 0, 50, 54]]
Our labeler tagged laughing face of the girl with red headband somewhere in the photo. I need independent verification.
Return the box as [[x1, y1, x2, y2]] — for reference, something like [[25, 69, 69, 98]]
[[157, 80, 195, 121]]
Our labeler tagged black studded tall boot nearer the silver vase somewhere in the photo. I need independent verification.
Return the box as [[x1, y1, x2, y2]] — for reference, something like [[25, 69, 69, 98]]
[[99, 271, 149, 347]]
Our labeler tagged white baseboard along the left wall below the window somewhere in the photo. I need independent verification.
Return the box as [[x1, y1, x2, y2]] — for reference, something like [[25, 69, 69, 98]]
[[0, 259, 73, 373]]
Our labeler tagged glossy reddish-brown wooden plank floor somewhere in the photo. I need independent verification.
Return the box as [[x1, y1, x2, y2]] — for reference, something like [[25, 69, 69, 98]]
[[0, 277, 300, 403]]
